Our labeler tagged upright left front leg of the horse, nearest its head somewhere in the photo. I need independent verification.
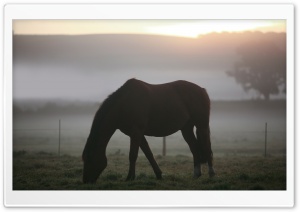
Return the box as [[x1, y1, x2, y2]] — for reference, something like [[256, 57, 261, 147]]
[[126, 131, 143, 181]]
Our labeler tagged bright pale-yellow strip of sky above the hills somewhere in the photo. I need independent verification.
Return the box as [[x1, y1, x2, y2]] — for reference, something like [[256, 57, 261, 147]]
[[13, 20, 285, 38]]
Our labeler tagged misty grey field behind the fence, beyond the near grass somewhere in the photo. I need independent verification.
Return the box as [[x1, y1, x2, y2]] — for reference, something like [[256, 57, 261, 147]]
[[13, 100, 286, 156]]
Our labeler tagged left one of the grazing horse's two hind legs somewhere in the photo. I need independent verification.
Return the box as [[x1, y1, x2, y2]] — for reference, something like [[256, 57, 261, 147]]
[[181, 125, 201, 178]]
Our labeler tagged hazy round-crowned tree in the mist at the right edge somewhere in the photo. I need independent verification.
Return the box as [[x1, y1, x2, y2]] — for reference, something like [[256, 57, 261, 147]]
[[227, 41, 286, 100]]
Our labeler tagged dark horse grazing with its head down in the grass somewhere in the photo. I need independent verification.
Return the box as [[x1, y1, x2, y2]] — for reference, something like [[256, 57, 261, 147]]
[[82, 79, 215, 183]]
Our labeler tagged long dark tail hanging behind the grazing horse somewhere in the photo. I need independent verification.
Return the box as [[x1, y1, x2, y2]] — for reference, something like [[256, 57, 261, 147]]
[[196, 89, 213, 163]]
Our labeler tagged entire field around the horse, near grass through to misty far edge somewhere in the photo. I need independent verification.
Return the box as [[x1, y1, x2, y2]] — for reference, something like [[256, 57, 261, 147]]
[[13, 100, 291, 190]]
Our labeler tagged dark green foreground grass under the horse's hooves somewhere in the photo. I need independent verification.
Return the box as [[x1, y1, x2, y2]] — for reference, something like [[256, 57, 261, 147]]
[[13, 151, 286, 190]]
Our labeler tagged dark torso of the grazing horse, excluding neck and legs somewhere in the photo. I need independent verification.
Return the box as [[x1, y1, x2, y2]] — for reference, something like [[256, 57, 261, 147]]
[[119, 79, 209, 136]]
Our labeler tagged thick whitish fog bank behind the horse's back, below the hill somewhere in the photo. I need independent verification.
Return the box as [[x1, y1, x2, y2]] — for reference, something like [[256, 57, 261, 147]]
[[13, 67, 251, 101]]
